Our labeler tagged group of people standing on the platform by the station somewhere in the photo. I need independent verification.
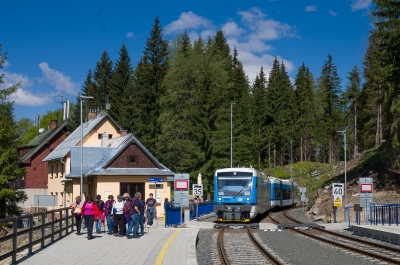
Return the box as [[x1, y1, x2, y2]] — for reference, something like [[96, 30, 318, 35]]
[[71, 192, 157, 240]]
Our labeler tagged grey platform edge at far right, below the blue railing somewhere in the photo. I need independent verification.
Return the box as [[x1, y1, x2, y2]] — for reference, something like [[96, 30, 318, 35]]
[[352, 222, 400, 245]]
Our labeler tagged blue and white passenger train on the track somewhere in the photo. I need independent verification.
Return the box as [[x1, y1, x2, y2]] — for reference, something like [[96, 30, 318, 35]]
[[214, 168, 297, 222]]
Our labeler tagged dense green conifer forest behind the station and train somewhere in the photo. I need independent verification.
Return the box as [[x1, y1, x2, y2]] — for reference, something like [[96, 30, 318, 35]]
[[0, 0, 400, 206]]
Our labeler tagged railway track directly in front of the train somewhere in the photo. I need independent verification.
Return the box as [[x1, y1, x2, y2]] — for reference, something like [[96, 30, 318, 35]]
[[217, 227, 286, 265]]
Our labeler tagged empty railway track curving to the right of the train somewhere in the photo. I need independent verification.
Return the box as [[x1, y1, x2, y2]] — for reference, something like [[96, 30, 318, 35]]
[[269, 207, 400, 264]]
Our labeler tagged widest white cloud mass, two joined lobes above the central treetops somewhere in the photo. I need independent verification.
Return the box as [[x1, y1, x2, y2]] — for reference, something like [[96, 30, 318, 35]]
[[164, 8, 297, 83]]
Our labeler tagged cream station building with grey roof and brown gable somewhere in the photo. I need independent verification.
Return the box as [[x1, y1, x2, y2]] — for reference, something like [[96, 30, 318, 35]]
[[43, 113, 174, 217]]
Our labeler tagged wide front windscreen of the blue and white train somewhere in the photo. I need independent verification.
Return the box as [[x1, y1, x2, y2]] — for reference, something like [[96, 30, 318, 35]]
[[218, 175, 251, 196]]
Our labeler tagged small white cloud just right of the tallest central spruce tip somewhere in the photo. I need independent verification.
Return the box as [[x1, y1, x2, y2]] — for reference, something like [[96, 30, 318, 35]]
[[164, 11, 211, 34]]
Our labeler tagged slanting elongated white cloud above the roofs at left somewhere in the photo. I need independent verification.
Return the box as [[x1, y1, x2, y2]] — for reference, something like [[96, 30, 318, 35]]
[[39, 62, 79, 95]]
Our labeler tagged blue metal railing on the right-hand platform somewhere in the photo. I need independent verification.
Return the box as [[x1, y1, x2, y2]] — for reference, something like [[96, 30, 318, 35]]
[[345, 203, 400, 226]]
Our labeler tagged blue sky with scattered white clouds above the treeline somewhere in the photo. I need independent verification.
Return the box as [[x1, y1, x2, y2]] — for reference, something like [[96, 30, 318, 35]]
[[0, 0, 372, 119]]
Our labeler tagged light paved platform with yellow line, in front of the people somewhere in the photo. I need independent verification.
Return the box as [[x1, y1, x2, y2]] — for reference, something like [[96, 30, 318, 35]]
[[18, 225, 199, 265]]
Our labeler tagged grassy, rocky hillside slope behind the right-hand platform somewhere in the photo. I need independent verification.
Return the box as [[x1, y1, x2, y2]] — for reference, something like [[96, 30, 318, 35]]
[[264, 147, 400, 222]]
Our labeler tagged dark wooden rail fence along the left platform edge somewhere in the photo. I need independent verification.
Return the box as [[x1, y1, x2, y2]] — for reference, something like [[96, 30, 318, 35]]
[[0, 208, 74, 263]]
